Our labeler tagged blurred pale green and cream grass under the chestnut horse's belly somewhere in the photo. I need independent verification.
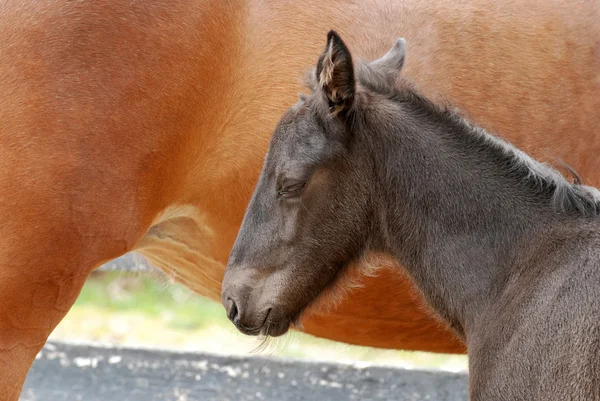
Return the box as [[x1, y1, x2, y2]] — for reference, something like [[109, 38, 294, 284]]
[[50, 254, 467, 372]]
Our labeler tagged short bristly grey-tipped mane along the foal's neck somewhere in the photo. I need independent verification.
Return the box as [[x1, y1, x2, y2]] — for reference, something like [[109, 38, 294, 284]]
[[305, 64, 600, 217]]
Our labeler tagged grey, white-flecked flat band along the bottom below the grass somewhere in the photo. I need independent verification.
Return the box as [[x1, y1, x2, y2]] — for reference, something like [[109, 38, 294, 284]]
[[21, 342, 467, 401]]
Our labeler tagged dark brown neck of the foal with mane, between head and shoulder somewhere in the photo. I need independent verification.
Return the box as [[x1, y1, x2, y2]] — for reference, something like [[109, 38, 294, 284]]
[[360, 88, 600, 337]]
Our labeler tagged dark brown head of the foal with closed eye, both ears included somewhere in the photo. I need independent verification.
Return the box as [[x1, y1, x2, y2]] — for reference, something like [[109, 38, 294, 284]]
[[218, 31, 405, 336]]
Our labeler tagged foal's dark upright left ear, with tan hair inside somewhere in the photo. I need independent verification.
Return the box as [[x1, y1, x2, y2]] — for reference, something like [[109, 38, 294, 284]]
[[316, 31, 356, 116]]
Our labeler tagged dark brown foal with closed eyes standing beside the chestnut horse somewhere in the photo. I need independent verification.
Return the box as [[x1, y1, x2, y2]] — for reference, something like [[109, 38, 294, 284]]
[[223, 32, 600, 401]]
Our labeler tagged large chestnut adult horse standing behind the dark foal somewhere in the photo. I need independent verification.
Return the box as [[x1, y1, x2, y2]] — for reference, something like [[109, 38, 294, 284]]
[[0, 0, 600, 401]]
